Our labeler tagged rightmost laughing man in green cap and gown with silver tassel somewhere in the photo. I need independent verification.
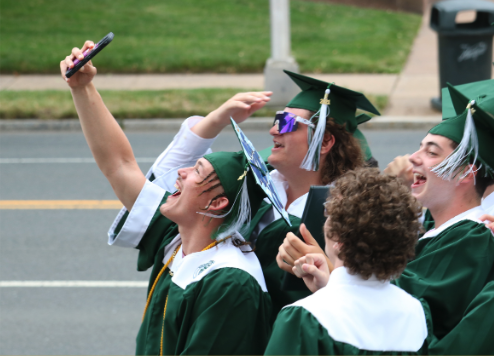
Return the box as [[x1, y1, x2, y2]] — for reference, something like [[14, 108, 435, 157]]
[[396, 81, 494, 354]]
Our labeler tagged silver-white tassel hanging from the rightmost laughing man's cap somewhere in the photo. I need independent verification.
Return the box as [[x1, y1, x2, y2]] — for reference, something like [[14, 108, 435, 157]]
[[431, 100, 479, 180]]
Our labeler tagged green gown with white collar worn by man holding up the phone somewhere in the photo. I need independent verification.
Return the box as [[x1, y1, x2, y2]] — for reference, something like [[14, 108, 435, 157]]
[[113, 185, 272, 355]]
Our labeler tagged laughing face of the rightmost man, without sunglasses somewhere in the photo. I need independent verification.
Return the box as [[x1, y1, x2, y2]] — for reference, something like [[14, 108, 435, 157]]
[[409, 134, 457, 210]]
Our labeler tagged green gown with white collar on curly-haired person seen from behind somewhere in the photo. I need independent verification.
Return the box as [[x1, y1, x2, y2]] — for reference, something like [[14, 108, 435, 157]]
[[265, 267, 431, 355]]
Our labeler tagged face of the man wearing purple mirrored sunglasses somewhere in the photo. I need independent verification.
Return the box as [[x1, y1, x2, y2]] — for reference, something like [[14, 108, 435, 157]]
[[268, 108, 311, 174]]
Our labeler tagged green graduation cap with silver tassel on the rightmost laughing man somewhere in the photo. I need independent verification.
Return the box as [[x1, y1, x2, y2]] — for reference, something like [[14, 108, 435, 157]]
[[429, 80, 494, 179]]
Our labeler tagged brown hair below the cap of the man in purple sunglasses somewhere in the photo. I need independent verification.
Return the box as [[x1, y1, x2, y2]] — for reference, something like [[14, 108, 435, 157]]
[[321, 118, 364, 184]]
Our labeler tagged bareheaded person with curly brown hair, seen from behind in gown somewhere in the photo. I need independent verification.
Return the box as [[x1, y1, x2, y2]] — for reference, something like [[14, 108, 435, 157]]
[[266, 169, 432, 355]]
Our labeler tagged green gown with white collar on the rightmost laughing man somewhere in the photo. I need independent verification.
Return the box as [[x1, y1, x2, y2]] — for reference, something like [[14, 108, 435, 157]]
[[395, 207, 494, 340]]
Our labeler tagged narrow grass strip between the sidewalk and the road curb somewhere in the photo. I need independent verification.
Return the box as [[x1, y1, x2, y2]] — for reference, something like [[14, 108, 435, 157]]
[[0, 89, 388, 119]]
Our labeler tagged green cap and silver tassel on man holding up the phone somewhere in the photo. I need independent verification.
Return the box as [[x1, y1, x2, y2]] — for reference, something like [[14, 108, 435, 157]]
[[199, 152, 266, 240]]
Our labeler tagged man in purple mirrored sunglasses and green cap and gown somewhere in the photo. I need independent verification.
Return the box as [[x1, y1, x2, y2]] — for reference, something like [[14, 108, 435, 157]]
[[256, 71, 379, 318]]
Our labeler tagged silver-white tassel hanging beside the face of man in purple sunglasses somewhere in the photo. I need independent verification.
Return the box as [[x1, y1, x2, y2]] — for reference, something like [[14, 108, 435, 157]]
[[300, 89, 330, 171]]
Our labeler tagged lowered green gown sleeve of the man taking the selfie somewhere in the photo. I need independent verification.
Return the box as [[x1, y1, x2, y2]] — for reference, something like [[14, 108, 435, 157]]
[[176, 268, 271, 355]]
